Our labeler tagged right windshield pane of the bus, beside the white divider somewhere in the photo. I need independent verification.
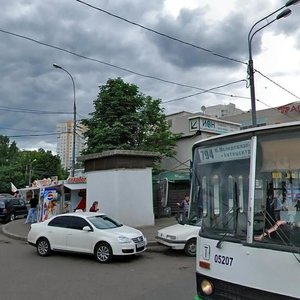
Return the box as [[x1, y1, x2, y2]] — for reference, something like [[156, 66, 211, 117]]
[[254, 132, 300, 246]]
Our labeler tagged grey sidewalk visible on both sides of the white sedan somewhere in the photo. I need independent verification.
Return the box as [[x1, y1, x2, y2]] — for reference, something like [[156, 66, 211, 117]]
[[2, 216, 177, 246]]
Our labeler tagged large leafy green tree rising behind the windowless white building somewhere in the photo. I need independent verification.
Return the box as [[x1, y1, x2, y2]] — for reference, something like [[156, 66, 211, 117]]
[[82, 78, 178, 156]]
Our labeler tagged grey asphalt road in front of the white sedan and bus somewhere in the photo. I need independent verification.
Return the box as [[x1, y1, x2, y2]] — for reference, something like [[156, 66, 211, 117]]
[[0, 225, 196, 300]]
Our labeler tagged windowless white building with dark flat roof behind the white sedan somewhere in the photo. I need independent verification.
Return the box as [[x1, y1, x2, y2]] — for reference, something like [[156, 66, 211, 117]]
[[79, 150, 158, 227]]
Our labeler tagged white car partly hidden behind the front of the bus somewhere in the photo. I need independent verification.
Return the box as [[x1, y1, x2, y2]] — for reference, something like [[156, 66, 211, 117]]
[[155, 219, 201, 256]]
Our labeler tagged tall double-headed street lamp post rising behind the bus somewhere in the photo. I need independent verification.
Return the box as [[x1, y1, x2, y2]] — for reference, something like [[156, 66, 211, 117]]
[[248, 0, 300, 127]]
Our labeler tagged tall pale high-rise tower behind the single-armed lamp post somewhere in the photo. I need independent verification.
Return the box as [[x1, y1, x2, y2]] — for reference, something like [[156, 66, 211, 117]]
[[56, 121, 86, 170]]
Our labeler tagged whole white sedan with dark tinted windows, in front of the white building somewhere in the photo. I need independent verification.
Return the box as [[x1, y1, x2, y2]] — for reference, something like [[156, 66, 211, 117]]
[[27, 212, 147, 263]]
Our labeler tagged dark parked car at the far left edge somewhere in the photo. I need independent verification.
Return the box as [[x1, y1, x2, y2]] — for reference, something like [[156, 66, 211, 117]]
[[0, 195, 28, 222]]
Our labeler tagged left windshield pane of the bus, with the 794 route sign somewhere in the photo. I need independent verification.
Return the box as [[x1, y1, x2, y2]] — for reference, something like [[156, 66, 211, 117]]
[[190, 139, 251, 243]]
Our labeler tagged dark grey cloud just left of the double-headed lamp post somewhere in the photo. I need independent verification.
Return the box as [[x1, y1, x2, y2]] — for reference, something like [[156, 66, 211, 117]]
[[148, 9, 255, 69]]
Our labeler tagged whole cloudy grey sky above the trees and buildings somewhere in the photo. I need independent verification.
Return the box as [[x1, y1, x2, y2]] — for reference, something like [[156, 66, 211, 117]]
[[0, 0, 300, 153]]
